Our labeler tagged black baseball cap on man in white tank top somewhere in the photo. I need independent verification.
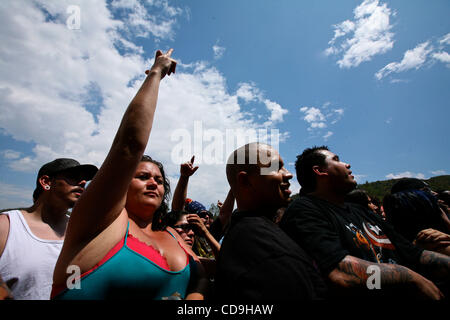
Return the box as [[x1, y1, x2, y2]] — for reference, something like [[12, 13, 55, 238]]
[[33, 158, 98, 200]]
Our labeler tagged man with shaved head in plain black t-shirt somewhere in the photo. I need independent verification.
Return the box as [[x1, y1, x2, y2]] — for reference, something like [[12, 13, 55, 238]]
[[215, 143, 326, 302]]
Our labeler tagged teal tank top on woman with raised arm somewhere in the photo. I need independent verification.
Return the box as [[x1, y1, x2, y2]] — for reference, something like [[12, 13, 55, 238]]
[[52, 222, 192, 300]]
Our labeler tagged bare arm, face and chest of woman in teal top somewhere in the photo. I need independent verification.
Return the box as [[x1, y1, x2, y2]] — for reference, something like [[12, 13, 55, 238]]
[[53, 49, 205, 299]]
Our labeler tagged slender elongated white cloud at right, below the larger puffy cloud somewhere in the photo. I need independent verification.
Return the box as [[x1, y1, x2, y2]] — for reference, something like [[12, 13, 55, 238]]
[[375, 41, 433, 80]]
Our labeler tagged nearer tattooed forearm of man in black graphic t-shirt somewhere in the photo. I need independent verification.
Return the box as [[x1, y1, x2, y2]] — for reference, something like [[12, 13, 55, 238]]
[[328, 255, 443, 300]]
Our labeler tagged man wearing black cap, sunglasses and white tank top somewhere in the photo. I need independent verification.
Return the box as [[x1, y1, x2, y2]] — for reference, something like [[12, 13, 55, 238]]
[[0, 158, 98, 300]]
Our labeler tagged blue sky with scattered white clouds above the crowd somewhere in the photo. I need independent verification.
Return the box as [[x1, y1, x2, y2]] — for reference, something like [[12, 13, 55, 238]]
[[0, 0, 450, 208]]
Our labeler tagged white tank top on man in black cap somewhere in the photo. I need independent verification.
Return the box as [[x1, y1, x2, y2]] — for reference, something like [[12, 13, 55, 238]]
[[0, 210, 63, 300]]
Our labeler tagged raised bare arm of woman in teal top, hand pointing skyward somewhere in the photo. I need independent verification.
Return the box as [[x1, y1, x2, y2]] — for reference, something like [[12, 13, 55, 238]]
[[55, 49, 176, 274]]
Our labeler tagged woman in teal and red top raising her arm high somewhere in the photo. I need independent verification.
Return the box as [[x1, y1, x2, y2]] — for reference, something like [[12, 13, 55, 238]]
[[52, 49, 207, 300]]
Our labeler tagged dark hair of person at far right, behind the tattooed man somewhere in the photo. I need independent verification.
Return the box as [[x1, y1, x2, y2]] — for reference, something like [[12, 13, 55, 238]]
[[383, 190, 448, 241]]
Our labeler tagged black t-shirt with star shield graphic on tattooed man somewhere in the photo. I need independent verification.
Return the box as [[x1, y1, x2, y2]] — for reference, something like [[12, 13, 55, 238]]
[[280, 196, 423, 276]]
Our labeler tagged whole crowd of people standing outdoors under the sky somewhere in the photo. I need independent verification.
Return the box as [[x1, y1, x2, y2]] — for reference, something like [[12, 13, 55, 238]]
[[0, 49, 450, 303]]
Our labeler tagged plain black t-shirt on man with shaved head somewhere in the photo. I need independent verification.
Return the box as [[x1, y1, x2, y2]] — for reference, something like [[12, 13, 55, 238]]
[[214, 212, 327, 302]]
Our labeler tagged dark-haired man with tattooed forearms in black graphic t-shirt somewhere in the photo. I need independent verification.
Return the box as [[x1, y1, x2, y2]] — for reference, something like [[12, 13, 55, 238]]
[[280, 146, 450, 300]]
